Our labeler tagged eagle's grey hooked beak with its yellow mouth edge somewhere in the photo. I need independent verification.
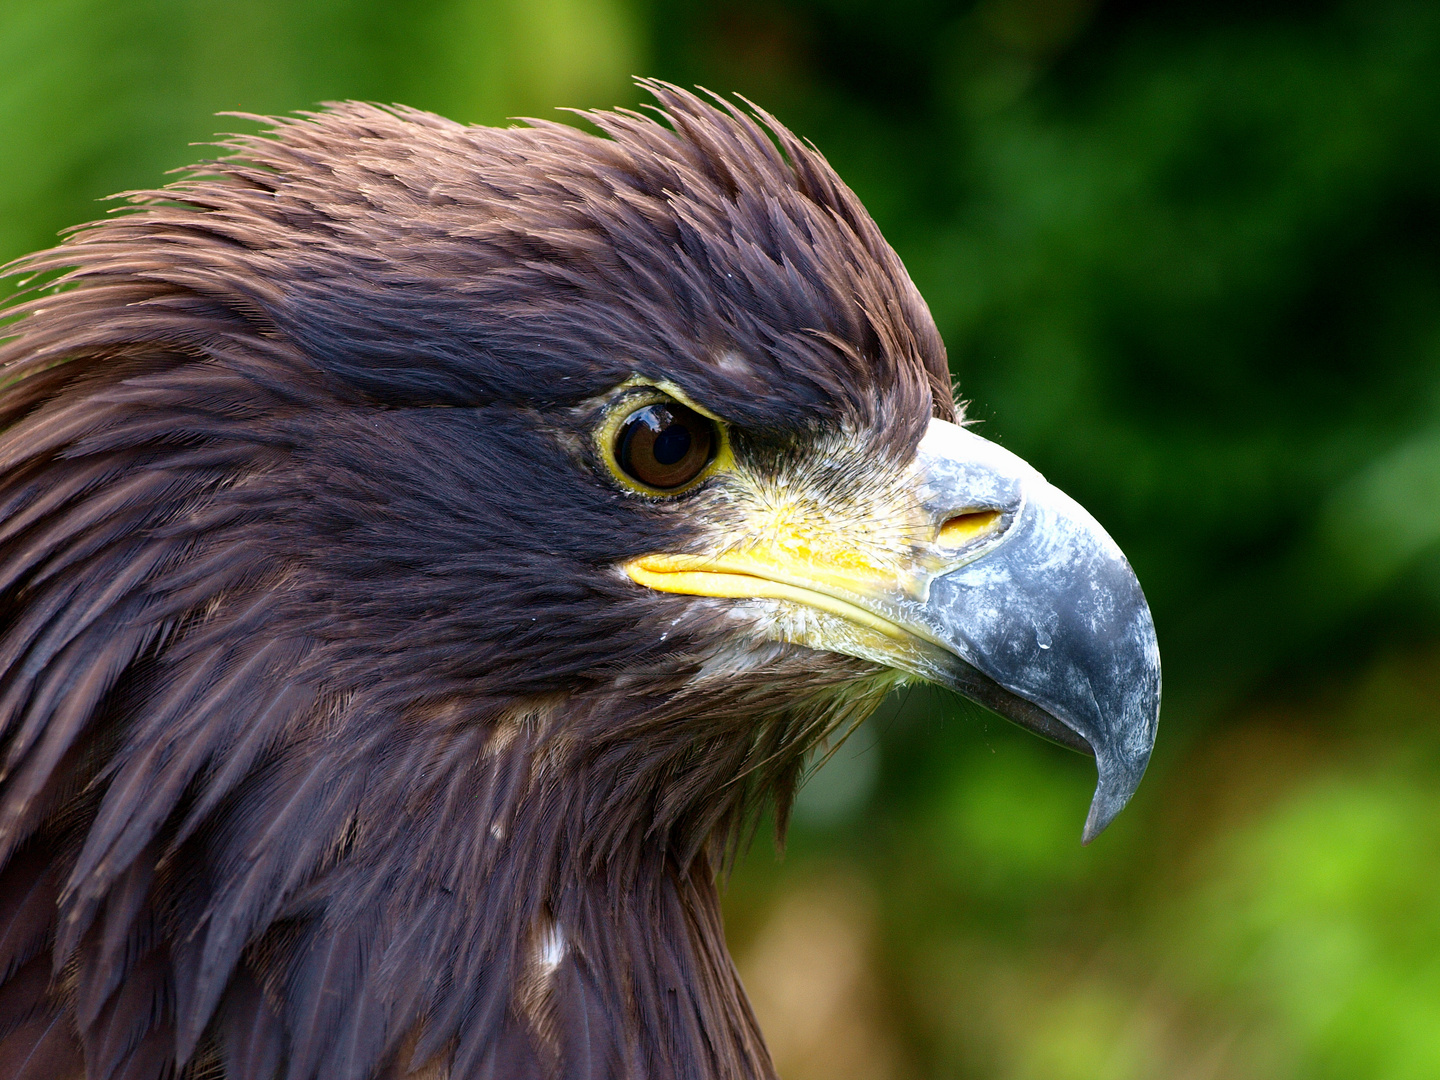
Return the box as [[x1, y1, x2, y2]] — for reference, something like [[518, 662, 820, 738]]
[[625, 419, 1161, 842]]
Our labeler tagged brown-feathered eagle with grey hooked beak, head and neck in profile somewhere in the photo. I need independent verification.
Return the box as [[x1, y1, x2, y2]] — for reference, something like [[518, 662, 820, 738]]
[[0, 82, 1159, 1080]]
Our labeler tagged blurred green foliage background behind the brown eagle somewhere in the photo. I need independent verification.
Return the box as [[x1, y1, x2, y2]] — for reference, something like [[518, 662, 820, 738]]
[[8, 0, 1440, 1080]]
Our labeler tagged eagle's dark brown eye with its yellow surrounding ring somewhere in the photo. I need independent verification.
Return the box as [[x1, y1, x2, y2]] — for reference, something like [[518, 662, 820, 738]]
[[596, 387, 730, 498]]
